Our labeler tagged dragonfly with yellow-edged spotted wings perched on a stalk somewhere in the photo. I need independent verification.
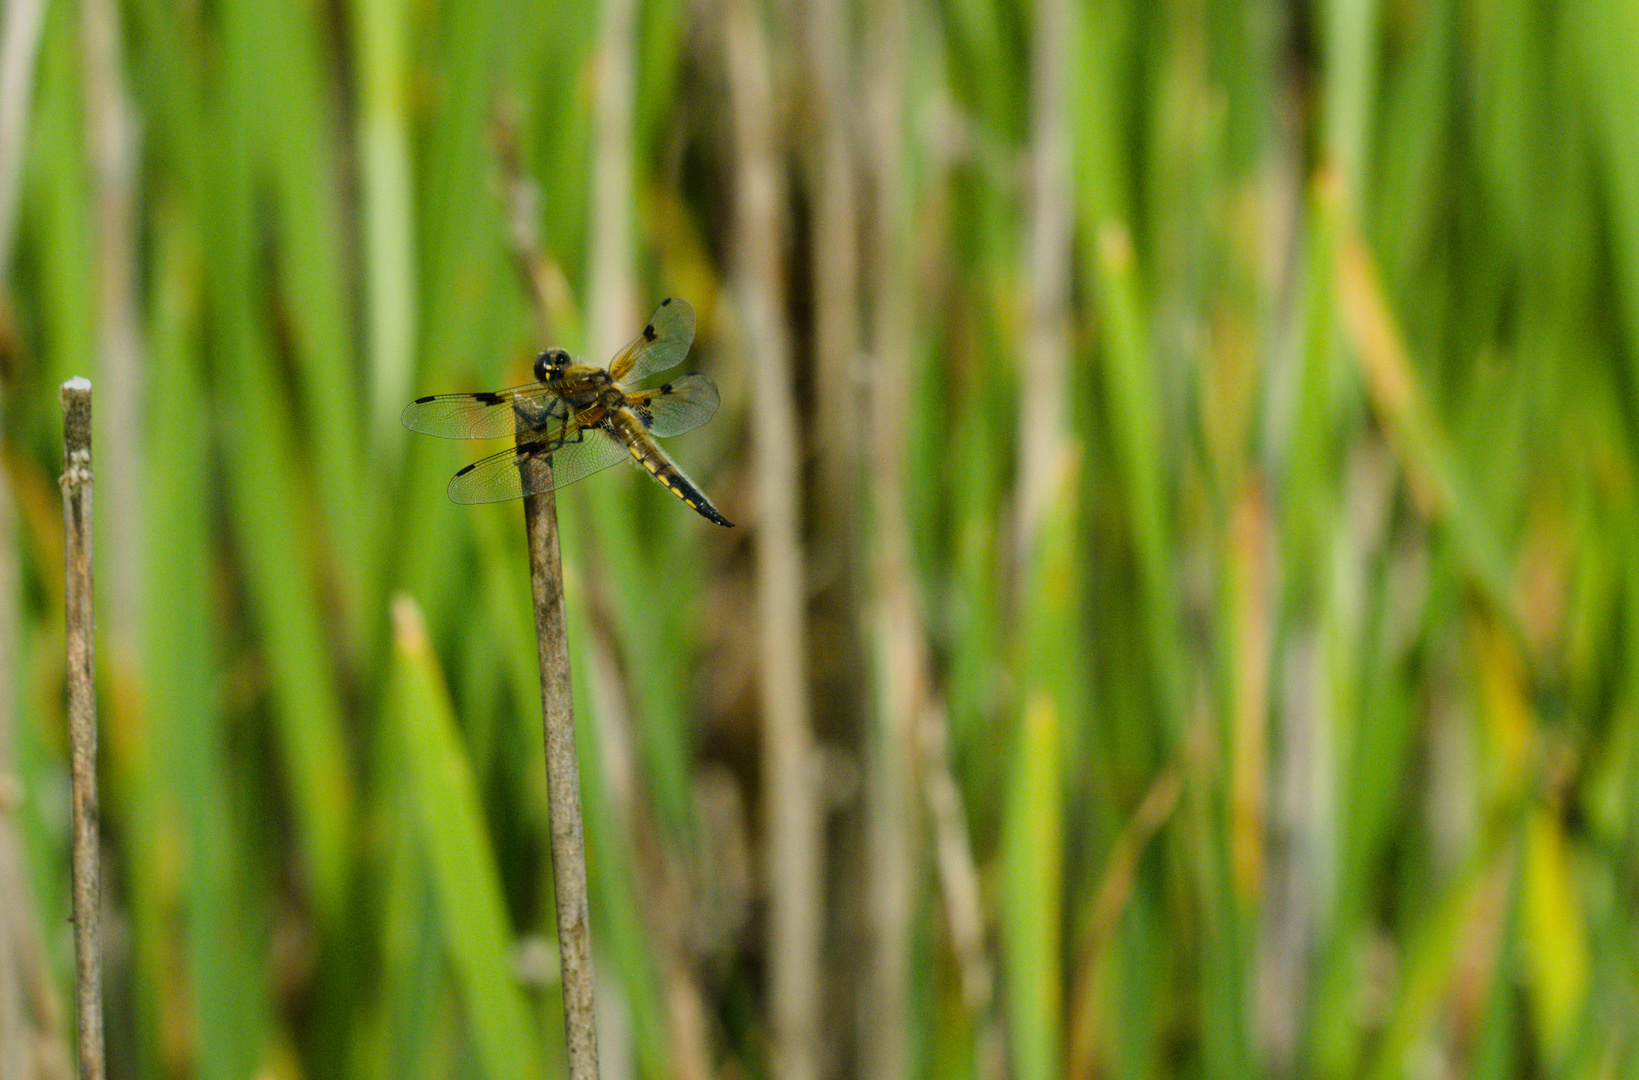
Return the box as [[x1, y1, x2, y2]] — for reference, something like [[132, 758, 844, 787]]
[[400, 297, 734, 528]]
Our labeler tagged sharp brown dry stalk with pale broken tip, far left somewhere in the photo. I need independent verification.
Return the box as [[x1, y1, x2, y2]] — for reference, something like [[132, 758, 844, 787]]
[[62, 379, 103, 1080]]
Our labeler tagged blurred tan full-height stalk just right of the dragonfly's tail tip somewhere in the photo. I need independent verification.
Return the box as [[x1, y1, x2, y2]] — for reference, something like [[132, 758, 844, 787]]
[[723, 0, 823, 1080]]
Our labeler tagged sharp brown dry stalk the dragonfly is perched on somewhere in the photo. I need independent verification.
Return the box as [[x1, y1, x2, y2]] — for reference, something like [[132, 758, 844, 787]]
[[518, 456, 598, 1080]]
